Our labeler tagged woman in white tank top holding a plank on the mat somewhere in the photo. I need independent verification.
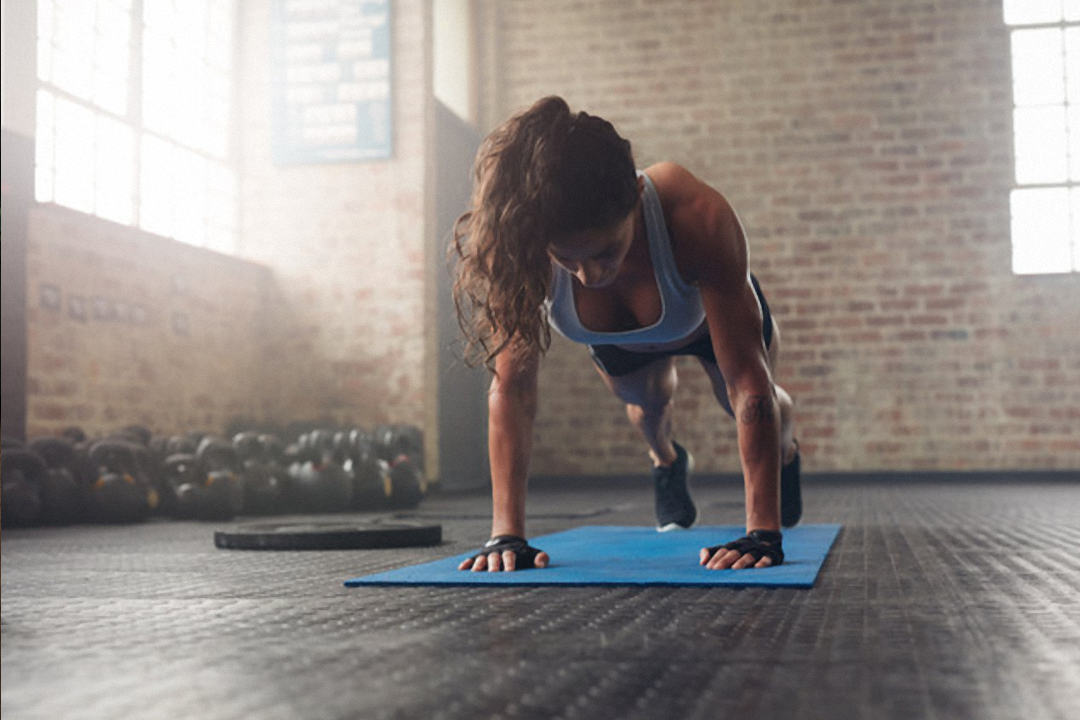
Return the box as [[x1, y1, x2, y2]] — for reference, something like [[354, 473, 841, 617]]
[[453, 97, 801, 572]]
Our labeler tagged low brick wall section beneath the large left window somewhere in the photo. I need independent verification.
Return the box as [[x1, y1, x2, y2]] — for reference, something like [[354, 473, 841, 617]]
[[26, 205, 273, 437]]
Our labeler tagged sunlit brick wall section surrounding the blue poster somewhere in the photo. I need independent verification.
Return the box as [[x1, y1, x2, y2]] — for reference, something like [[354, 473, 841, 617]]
[[240, 0, 433, 433]]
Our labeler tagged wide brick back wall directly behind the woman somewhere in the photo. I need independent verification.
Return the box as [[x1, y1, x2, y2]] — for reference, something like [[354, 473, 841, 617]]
[[481, 0, 1080, 474]]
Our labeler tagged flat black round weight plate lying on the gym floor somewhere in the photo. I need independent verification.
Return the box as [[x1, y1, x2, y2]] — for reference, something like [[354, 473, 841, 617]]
[[214, 522, 443, 551]]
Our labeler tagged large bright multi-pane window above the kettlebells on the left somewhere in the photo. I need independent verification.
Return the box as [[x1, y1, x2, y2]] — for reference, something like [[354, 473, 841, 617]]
[[35, 0, 237, 252]]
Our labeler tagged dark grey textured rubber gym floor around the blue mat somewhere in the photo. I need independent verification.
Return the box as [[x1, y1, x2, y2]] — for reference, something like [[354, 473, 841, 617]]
[[2, 480, 1080, 720]]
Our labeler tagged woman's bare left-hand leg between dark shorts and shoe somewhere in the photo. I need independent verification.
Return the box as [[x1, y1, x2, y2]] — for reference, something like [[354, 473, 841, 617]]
[[596, 357, 678, 465]]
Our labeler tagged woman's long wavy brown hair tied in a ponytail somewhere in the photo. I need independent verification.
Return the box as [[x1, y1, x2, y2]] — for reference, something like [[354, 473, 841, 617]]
[[449, 96, 638, 370]]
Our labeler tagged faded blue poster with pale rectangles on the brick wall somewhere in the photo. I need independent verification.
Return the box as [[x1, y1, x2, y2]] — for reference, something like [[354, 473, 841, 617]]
[[270, 0, 393, 164]]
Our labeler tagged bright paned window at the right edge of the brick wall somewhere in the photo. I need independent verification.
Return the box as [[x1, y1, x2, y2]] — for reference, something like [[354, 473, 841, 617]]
[[1004, 0, 1080, 274]]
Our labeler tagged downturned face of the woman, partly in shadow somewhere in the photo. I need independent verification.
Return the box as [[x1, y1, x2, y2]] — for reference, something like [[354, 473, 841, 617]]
[[548, 205, 640, 287]]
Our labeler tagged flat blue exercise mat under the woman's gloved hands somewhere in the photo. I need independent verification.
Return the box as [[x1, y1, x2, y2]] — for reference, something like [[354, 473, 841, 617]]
[[346, 525, 840, 587]]
